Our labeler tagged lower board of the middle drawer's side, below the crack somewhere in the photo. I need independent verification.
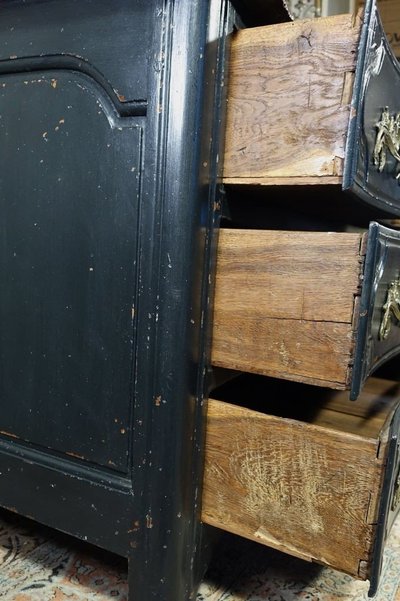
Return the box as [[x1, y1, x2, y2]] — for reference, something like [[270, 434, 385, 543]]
[[212, 316, 353, 389]]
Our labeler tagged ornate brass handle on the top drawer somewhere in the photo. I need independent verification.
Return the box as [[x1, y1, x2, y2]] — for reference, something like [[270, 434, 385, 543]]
[[373, 107, 400, 181]]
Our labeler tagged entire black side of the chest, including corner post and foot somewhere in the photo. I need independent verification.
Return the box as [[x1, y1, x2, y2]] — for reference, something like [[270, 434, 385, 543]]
[[0, 0, 234, 601]]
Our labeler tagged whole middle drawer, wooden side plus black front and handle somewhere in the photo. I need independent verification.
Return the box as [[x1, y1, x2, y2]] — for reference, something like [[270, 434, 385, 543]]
[[212, 223, 400, 399]]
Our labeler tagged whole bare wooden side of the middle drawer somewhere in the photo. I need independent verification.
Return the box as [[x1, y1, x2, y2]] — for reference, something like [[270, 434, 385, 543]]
[[212, 229, 363, 388]]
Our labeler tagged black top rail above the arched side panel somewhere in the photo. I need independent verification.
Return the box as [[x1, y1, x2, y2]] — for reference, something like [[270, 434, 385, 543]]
[[0, 0, 154, 102]]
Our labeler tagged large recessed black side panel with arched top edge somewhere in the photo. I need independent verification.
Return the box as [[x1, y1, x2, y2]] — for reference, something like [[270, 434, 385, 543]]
[[0, 70, 142, 471]]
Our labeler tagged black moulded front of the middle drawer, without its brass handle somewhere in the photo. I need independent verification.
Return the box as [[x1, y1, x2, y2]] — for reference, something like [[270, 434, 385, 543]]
[[351, 222, 400, 400]]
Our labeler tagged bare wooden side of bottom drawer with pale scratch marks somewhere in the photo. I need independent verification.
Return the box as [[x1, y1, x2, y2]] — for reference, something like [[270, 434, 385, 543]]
[[202, 376, 394, 578]]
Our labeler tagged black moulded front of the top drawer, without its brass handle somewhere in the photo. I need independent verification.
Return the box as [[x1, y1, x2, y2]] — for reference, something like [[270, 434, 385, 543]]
[[343, 0, 400, 215]]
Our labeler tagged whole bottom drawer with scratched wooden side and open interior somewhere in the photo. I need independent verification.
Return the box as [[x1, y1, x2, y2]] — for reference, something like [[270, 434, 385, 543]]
[[202, 376, 400, 593]]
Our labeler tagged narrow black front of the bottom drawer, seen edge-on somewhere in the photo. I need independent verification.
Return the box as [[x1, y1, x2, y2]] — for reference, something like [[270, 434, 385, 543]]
[[368, 405, 400, 597]]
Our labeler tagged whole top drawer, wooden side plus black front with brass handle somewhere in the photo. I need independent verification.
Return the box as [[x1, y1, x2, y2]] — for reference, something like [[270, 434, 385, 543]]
[[223, 0, 400, 215]]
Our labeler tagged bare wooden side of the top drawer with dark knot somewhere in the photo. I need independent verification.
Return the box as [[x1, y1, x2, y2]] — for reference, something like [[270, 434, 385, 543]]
[[223, 15, 361, 184]]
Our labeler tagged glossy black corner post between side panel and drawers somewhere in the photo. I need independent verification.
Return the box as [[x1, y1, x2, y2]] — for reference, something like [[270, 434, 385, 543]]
[[129, 0, 231, 601]]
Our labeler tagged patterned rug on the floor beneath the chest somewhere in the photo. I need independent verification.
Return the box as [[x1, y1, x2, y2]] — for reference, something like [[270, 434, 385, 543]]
[[0, 512, 400, 601]]
